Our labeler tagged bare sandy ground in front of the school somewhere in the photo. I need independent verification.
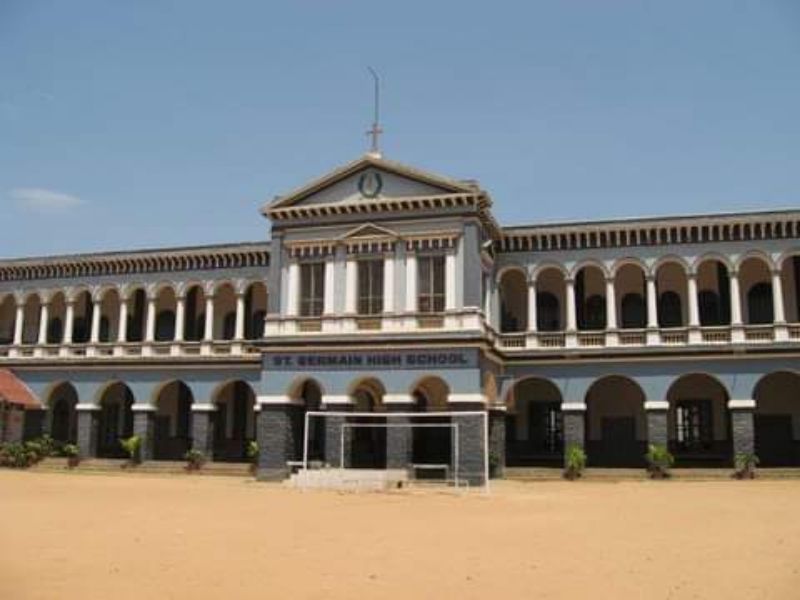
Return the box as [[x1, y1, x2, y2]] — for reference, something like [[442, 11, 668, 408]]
[[0, 471, 800, 600]]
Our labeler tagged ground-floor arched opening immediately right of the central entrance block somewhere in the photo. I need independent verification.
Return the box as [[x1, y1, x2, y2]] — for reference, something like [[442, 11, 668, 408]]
[[506, 377, 564, 467]]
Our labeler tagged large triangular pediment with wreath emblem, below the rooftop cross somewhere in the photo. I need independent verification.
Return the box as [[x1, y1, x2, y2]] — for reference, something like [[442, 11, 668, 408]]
[[263, 155, 478, 214]]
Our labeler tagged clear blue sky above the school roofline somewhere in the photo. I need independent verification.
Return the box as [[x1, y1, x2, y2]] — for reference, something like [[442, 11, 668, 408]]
[[0, 0, 800, 257]]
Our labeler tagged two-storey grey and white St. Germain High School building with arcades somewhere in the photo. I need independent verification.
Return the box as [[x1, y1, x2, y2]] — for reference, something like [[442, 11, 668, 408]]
[[0, 154, 800, 479]]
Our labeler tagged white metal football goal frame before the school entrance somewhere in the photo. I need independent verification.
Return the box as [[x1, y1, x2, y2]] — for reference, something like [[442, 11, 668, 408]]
[[303, 410, 489, 491]]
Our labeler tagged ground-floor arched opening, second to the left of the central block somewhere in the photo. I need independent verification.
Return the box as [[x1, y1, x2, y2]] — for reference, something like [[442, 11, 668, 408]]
[[153, 381, 194, 460]]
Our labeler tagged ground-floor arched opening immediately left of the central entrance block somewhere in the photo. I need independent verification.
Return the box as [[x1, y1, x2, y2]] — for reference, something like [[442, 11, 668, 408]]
[[214, 380, 256, 462]]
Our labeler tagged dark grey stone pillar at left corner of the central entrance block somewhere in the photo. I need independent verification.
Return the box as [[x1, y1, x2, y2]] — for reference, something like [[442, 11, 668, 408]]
[[256, 404, 303, 481]]
